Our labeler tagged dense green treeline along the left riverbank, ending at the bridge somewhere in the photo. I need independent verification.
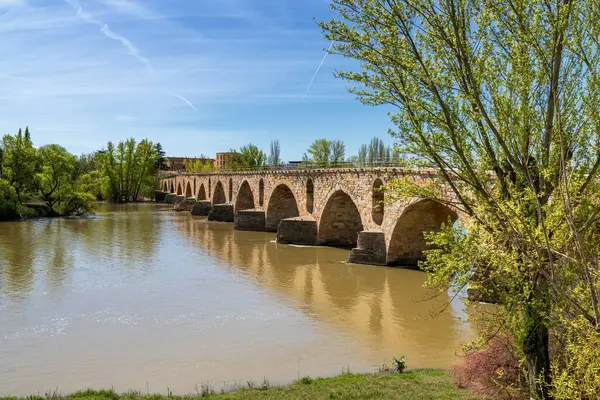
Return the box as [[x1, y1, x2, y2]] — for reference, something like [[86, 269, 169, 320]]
[[0, 128, 165, 220]]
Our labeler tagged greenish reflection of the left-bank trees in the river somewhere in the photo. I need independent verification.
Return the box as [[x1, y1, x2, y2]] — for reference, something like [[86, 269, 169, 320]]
[[0, 204, 166, 299]]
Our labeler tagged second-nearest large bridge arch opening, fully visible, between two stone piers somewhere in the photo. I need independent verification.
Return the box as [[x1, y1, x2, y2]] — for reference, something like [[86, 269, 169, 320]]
[[318, 190, 363, 246]]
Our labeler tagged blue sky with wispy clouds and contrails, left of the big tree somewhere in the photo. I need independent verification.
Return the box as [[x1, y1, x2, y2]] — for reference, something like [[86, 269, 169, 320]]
[[0, 0, 392, 160]]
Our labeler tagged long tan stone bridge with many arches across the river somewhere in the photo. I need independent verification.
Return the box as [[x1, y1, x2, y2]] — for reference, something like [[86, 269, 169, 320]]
[[157, 168, 462, 266]]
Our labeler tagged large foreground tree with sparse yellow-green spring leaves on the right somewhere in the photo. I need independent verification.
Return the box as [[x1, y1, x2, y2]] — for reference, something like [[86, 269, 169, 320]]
[[321, 0, 600, 398]]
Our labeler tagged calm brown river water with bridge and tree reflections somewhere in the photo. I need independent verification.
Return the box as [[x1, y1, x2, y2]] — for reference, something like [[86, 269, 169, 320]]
[[0, 205, 472, 395]]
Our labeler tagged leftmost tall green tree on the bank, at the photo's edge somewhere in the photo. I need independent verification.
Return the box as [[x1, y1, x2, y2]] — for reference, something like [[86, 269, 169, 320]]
[[2, 129, 37, 204]]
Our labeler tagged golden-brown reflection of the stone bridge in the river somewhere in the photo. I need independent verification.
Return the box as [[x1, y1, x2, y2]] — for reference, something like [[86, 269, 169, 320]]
[[175, 213, 473, 368]]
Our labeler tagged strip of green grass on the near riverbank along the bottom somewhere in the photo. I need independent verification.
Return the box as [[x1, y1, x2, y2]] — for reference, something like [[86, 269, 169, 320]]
[[0, 370, 475, 400]]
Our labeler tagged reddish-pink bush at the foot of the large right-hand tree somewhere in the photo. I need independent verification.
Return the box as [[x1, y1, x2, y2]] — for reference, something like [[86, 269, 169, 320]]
[[452, 336, 527, 399]]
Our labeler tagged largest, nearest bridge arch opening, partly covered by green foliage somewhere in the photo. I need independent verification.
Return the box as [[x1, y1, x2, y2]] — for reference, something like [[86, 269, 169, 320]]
[[387, 200, 458, 267]]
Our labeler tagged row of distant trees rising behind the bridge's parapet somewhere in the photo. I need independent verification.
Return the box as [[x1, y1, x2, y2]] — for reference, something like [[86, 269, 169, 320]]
[[184, 137, 402, 173]]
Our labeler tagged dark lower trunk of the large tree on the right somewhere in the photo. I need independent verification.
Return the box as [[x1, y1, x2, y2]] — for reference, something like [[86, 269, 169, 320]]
[[523, 275, 552, 400]]
